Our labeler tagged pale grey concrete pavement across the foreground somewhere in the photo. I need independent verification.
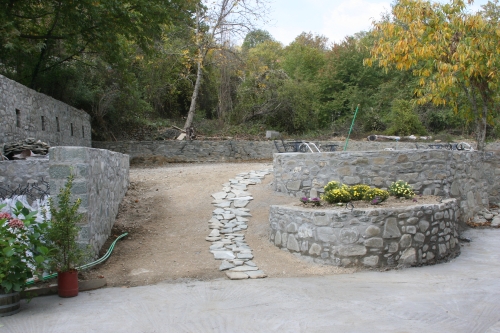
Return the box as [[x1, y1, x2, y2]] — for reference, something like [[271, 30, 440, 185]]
[[0, 229, 500, 333]]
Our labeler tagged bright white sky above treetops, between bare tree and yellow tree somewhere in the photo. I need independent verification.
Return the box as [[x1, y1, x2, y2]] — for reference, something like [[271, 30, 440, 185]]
[[268, 0, 487, 45]]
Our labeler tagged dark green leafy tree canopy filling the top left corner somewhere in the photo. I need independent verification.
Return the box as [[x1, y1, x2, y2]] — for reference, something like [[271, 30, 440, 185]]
[[0, 0, 192, 88]]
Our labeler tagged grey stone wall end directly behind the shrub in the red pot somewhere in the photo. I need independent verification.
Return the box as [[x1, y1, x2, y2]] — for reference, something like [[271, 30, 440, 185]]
[[49, 147, 129, 255]]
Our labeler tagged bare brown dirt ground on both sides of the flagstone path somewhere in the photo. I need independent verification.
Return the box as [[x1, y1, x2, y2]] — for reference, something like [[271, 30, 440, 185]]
[[83, 163, 353, 286]]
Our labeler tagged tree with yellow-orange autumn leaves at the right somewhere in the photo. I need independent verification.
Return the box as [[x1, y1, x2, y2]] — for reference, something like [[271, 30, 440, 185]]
[[365, 0, 500, 150]]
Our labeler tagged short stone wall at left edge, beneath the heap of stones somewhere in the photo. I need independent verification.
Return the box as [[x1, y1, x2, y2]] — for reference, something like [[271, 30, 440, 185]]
[[0, 158, 49, 190]]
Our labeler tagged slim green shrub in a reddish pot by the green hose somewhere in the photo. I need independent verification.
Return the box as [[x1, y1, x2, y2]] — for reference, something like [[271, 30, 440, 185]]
[[47, 174, 88, 297]]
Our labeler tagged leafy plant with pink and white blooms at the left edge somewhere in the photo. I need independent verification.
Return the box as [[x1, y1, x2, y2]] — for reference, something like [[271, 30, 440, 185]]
[[0, 201, 49, 293]]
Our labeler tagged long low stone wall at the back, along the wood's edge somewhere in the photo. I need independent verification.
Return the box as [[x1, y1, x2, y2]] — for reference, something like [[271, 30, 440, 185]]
[[92, 140, 427, 163]]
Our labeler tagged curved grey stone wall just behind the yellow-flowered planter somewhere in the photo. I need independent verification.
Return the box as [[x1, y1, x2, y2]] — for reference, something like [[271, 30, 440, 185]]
[[273, 150, 489, 226]]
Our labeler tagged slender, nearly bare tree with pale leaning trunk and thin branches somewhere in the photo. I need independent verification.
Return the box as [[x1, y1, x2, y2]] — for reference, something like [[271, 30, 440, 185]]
[[184, 0, 268, 129]]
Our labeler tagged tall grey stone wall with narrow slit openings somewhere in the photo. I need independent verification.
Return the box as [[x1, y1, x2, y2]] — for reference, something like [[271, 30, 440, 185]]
[[0, 75, 91, 147]]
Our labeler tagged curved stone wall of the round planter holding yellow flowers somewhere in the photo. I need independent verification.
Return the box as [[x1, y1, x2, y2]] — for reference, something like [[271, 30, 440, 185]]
[[269, 199, 460, 268]]
